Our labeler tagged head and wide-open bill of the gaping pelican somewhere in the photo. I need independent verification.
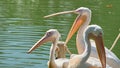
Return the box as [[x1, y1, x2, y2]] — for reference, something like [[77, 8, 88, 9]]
[[44, 7, 91, 43]]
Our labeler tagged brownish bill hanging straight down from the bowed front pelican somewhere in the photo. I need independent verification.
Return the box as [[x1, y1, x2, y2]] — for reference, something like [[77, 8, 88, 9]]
[[95, 36, 106, 68]]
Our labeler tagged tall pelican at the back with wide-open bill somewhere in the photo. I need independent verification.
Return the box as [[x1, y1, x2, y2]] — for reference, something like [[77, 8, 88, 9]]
[[44, 7, 120, 68]]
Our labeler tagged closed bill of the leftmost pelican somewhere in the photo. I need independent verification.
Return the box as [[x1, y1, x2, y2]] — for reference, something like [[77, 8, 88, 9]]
[[28, 35, 50, 53]]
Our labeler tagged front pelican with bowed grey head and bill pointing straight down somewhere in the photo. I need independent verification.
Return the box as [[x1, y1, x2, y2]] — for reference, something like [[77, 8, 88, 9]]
[[68, 25, 111, 68]]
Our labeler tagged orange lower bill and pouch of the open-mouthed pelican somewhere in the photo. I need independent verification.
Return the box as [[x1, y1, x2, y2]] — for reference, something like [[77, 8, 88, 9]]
[[65, 15, 87, 43]]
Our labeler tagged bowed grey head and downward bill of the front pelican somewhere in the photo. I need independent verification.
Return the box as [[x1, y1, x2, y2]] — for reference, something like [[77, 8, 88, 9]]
[[83, 25, 106, 68]]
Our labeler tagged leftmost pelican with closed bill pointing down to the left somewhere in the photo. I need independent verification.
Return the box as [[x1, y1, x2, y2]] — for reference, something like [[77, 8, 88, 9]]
[[28, 29, 69, 68]]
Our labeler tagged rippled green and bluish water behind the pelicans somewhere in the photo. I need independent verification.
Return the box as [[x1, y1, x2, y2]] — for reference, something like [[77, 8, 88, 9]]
[[0, 0, 120, 68]]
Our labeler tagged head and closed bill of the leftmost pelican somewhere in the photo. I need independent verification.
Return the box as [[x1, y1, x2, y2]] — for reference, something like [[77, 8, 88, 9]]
[[28, 29, 60, 53]]
